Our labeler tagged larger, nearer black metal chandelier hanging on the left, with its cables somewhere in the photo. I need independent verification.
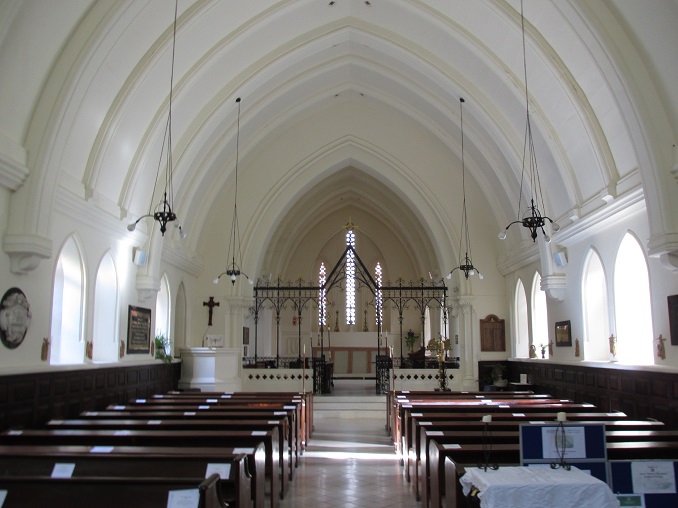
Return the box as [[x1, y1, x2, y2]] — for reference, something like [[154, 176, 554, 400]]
[[127, 0, 186, 238]]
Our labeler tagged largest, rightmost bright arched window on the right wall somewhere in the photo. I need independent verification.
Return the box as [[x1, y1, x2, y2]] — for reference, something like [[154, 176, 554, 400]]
[[614, 233, 654, 364]]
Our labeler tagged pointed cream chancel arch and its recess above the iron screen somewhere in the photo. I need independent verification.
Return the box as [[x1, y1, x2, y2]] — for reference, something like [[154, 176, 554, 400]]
[[243, 136, 458, 288]]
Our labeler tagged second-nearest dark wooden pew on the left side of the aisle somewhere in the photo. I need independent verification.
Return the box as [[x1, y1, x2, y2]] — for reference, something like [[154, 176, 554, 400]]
[[0, 445, 254, 508]]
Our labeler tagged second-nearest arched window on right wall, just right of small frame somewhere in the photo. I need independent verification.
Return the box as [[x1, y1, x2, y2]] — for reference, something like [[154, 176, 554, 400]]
[[581, 249, 610, 360]]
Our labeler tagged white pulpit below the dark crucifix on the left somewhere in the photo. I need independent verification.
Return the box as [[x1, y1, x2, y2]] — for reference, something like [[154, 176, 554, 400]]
[[179, 347, 242, 392]]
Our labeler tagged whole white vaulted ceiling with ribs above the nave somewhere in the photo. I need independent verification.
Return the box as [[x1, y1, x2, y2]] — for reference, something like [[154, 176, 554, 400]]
[[0, 0, 678, 278]]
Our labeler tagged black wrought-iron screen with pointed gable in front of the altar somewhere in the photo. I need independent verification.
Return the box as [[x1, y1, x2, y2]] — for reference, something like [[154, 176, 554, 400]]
[[253, 246, 448, 367]]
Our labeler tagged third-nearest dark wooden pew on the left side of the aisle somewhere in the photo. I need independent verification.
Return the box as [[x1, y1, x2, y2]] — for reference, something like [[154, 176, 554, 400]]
[[0, 428, 285, 508]]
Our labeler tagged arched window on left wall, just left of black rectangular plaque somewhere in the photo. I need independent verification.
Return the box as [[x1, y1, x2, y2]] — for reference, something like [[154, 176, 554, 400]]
[[92, 253, 119, 362]]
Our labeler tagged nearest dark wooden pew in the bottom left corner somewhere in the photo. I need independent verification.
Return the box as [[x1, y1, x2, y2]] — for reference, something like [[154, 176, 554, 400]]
[[0, 474, 228, 508]]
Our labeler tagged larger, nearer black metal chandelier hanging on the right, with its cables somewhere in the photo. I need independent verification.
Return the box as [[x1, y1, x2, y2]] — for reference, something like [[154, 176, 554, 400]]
[[499, 0, 560, 243]]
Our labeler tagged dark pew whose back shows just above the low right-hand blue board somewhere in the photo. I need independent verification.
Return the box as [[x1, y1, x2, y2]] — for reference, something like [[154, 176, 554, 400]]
[[432, 439, 678, 508]]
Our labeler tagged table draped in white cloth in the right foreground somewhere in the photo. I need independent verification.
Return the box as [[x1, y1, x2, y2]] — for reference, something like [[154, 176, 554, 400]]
[[459, 466, 619, 508]]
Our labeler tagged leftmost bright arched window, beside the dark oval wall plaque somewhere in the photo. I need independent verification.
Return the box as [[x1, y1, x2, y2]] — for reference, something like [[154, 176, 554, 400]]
[[50, 237, 85, 365]]
